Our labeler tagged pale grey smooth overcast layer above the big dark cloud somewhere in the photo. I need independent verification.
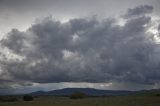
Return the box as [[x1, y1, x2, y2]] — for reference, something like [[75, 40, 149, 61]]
[[0, 0, 160, 35]]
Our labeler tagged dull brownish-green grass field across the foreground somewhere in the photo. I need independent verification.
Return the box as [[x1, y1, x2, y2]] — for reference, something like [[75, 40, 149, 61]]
[[0, 96, 160, 106]]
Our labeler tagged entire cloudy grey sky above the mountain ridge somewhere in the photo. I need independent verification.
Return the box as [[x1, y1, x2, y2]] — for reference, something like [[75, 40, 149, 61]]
[[0, 0, 160, 94]]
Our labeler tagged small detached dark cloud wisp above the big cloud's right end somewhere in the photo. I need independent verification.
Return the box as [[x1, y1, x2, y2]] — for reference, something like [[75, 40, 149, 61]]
[[124, 5, 153, 18]]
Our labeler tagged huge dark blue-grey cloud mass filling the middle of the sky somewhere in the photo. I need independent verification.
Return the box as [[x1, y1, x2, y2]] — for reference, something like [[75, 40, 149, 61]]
[[0, 6, 160, 89]]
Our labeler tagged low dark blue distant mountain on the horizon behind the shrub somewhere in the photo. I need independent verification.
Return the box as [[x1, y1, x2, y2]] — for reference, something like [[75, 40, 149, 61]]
[[30, 88, 134, 96]]
